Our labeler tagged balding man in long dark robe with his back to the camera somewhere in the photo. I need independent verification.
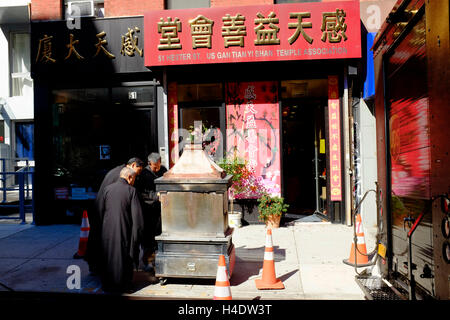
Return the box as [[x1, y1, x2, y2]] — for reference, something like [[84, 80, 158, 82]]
[[99, 168, 144, 292]]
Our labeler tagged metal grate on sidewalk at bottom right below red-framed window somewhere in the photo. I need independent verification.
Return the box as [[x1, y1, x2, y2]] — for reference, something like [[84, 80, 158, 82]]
[[355, 276, 403, 300]]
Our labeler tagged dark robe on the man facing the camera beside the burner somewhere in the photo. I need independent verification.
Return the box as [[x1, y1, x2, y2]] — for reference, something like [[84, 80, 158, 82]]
[[136, 166, 167, 252]]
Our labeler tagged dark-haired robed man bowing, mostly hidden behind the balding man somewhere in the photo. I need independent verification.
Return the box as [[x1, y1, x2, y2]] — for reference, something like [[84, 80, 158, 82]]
[[86, 158, 144, 273]]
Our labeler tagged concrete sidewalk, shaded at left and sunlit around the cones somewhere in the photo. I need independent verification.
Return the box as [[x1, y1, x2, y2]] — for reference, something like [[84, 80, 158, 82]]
[[0, 222, 369, 300]]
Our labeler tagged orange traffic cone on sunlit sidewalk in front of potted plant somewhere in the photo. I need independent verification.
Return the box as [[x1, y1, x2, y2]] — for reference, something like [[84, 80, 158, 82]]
[[255, 229, 284, 290]]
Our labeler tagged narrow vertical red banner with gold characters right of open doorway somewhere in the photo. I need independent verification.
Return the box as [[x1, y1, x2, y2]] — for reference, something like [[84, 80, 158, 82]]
[[328, 76, 342, 201]]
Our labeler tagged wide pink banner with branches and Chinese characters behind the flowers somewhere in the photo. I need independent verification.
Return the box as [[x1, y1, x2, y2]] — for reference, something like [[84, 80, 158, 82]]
[[226, 81, 281, 198]]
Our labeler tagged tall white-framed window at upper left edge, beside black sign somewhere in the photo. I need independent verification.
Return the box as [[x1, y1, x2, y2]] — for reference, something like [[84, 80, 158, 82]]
[[11, 33, 33, 97]]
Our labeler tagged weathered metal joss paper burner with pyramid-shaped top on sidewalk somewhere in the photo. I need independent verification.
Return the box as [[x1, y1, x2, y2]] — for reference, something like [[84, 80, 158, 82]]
[[155, 144, 235, 279]]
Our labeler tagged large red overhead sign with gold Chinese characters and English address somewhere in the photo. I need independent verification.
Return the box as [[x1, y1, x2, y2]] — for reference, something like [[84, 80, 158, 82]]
[[144, 1, 361, 67]]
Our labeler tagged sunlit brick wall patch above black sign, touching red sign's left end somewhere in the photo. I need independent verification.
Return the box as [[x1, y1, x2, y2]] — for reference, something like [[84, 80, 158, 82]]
[[105, 0, 164, 17]]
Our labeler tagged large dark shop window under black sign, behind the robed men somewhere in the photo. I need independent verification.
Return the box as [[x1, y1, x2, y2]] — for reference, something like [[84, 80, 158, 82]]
[[50, 85, 157, 191]]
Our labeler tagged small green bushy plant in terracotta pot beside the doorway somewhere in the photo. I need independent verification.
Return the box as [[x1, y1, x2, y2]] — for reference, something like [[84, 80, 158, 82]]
[[258, 193, 289, 229]]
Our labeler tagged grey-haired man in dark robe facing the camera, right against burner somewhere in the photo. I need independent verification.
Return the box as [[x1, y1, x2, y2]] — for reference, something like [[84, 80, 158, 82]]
[[136, 152, 167, 271]]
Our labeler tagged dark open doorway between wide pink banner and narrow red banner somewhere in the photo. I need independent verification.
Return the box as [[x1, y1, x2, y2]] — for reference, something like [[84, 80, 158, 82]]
[[281, 79, 328, 215]]
